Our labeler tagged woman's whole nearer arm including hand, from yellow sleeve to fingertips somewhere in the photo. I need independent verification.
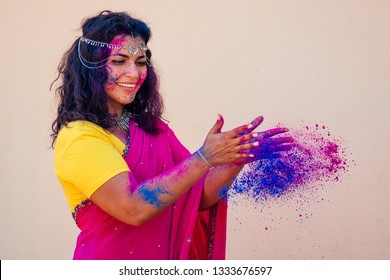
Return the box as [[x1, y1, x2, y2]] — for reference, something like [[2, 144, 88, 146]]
[[91, 115, 253, 225]]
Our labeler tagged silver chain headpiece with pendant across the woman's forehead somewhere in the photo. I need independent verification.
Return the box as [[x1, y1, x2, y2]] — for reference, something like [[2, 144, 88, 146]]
[[78, 36, 150, 69]]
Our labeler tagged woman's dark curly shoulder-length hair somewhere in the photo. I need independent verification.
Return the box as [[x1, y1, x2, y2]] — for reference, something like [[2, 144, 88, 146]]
[[50, 10, 163, 146]]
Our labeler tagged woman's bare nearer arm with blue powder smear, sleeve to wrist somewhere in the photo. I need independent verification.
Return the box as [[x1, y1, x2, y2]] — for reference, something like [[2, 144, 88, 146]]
[[91, 154, 208, 226]]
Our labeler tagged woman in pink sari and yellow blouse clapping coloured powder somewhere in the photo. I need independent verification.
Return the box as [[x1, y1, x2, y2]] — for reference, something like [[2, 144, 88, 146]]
[[52, 11, 292, 259]]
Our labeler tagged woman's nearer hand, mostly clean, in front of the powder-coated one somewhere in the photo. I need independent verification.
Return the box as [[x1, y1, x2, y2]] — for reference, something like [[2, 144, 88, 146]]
[[200, 115, 263, 166]]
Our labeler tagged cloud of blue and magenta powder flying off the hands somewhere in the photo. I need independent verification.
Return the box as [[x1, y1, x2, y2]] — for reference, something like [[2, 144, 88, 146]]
[[229, 124, 349, 203]]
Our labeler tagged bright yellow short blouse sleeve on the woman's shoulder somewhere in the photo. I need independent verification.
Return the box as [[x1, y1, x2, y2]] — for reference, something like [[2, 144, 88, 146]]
[[54, 121, 129, 211]]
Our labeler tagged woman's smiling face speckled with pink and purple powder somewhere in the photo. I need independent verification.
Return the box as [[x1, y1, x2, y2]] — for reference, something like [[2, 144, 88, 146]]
[[104, 35, 147, 113]]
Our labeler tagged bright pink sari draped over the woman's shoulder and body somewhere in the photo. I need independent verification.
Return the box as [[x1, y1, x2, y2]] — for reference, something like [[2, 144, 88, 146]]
[[73, 122, 227, 260]]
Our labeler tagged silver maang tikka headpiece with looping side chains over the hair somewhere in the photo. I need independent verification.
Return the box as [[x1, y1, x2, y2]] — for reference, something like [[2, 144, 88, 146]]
[[78, 35, 150, 69]]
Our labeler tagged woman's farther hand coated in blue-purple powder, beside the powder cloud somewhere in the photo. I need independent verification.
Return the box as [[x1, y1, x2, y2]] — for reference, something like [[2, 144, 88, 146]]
[[234, 125, 294, 165]]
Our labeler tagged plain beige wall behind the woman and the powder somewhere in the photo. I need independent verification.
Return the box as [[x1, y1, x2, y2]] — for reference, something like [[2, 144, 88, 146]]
[[0, 0, 390, 259]]
